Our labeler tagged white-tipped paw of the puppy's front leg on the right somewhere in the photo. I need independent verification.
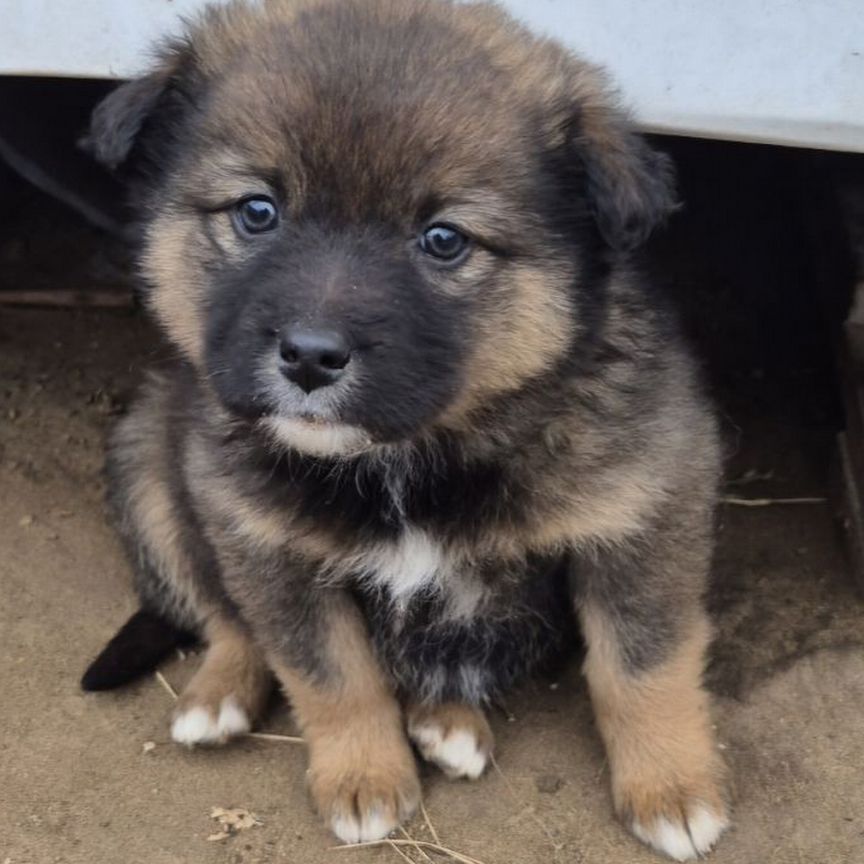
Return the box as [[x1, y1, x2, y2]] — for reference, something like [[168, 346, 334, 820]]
[[619, 780, 729, 861]]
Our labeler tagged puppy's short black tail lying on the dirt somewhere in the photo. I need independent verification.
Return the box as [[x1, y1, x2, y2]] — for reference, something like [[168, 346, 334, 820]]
[[81, 609, 198, 691]]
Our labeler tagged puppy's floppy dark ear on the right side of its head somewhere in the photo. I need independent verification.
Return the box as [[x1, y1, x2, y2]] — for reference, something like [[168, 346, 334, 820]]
[[570, 68, 678, 251]]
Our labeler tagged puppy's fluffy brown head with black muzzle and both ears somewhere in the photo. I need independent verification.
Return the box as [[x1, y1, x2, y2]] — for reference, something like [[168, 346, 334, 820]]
[[90, 0, 672, 453]]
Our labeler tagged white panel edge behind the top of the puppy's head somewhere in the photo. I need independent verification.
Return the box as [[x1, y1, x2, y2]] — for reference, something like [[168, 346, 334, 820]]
[[0, 0, 864, 152]]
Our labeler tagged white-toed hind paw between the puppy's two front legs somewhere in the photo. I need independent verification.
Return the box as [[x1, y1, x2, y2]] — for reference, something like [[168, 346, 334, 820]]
[[408, 702, 494, 780]]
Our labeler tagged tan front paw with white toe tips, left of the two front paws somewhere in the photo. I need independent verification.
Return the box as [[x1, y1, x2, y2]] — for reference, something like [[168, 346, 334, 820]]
[[309, 740, 420, 843]]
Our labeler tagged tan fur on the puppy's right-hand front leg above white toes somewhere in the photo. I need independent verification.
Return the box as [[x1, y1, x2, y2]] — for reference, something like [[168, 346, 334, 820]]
[[581, 606, 726, 825]]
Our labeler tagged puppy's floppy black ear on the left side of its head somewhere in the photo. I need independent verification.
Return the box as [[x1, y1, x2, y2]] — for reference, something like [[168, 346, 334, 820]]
[[80, 46, 190, 171]]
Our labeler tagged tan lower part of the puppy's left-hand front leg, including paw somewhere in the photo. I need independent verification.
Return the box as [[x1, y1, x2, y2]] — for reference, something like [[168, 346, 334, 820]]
[[270, 590, 420, 843]]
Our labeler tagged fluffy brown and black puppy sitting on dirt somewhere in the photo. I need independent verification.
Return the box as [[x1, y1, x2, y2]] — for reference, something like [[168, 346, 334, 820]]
[[84, 0, 727, 860]]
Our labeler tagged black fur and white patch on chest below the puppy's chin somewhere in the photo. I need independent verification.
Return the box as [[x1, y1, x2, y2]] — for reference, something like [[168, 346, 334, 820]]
[[280, 448, 540, 618]]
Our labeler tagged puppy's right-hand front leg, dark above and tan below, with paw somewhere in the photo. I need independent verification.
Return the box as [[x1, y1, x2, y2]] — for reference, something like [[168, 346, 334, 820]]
[[579, 532, 728, 861]]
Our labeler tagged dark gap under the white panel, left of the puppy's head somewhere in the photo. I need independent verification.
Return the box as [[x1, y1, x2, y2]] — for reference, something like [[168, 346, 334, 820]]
[[0, 76, 131, 305]]
